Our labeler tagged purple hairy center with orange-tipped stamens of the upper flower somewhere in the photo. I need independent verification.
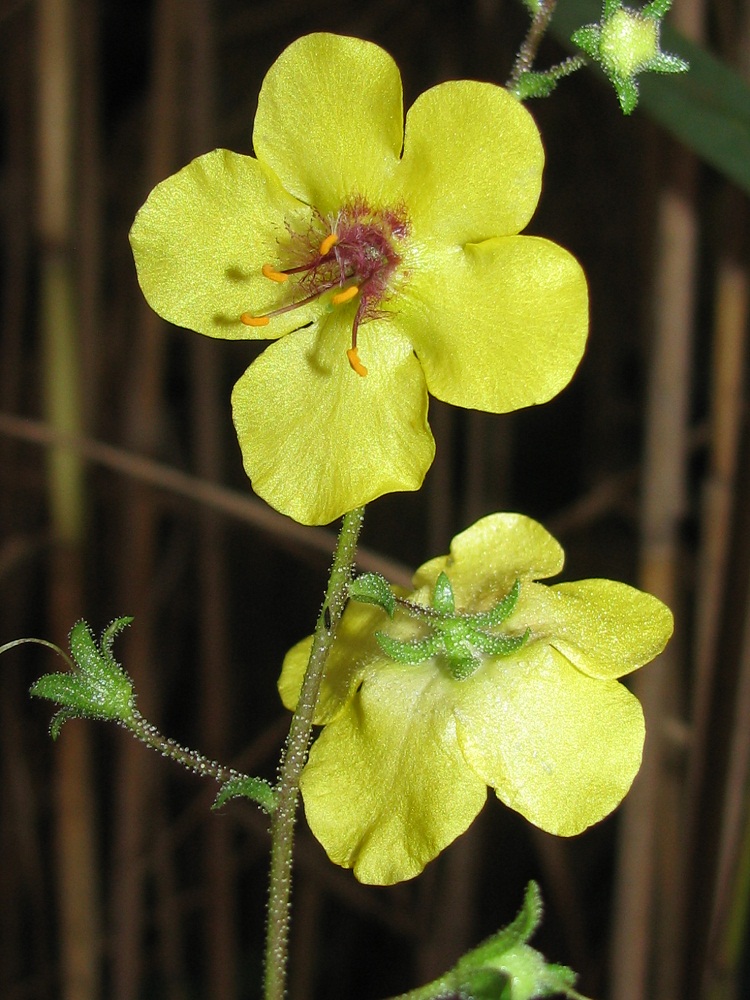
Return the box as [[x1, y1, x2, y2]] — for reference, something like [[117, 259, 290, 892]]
[[240, 198, 409, 376]]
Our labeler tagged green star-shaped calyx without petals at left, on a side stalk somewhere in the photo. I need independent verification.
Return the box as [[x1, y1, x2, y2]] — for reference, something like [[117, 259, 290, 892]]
[[30, 617, 135, 739]]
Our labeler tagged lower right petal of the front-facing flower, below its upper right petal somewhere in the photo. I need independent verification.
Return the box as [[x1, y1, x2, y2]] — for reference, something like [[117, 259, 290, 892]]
[[402, 236, 588, 413]]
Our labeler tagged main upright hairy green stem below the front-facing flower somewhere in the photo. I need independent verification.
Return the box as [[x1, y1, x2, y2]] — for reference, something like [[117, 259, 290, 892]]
[[264, 507, 364, 1000]]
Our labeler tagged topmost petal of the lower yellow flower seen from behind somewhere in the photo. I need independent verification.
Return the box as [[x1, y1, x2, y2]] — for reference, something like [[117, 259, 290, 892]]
[[414, 513, 564, 612]]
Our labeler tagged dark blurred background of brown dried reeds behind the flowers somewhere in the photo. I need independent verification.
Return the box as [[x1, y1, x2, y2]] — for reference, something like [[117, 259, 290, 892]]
[[0, 0, 750, 1000]]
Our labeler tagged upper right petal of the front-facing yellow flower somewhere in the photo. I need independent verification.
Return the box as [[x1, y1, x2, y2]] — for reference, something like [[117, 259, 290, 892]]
[[398, 80, 544, 246]]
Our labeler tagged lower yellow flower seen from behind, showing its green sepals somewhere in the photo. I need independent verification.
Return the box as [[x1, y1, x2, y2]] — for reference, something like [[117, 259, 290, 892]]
[[279, 514, 672, 885]]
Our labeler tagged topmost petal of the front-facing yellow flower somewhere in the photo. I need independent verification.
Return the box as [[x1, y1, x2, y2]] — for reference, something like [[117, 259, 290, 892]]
[[253, 33, 404, 215]]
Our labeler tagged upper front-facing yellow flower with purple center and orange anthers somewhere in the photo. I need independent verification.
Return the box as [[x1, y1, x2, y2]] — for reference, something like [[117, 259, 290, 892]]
[[131, 34, 588, 524]]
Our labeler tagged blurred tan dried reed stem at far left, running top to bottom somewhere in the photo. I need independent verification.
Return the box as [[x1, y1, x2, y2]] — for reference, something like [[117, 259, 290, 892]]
[[37, 0, 101, 1000]]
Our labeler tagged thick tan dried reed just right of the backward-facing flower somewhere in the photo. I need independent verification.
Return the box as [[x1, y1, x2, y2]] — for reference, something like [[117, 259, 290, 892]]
[[611, 117, 697, 1000]]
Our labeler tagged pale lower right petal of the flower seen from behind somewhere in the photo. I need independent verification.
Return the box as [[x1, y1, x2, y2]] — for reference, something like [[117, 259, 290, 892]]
[[456, 642, 645, 837]]
